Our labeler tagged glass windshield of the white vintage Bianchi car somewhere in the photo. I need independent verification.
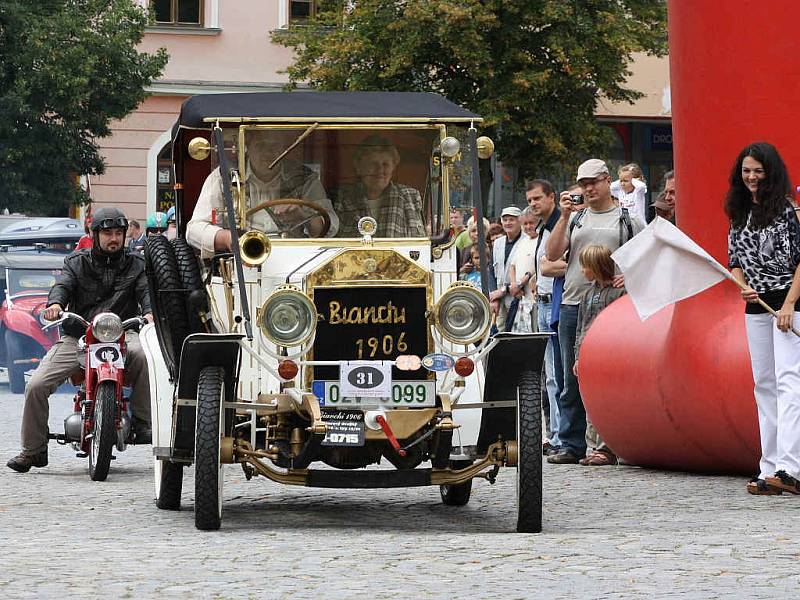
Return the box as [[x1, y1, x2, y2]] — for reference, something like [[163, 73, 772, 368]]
[[209, 125, 472, 239]]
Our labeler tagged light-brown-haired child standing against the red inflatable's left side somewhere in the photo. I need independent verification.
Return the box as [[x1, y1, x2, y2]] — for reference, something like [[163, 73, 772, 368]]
[[573, 244, 625, 467]]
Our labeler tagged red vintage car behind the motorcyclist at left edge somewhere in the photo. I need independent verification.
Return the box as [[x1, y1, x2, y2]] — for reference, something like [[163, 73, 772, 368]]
[[0, 250, 67, 394]]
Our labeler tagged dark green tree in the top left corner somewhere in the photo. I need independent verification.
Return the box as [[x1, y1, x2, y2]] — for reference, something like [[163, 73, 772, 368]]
[[0, 0, 167, 214]]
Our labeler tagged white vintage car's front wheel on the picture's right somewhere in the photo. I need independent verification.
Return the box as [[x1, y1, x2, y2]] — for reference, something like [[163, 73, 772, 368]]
[[517, 371, 542, 533]]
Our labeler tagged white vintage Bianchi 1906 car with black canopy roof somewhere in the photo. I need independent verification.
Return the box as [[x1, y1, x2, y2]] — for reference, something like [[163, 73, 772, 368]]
[[142, 92, 547, 532]]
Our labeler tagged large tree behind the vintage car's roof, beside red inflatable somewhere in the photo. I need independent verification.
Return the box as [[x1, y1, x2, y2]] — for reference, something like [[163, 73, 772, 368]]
[[272, 0, 667, 176]]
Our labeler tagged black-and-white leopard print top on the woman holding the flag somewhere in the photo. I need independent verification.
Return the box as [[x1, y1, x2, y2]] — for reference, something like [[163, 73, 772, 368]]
[[728, 201, 800, 294]]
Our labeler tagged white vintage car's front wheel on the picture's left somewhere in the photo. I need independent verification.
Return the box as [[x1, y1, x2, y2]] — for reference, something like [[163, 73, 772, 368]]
[[194, 367, 225, 529]]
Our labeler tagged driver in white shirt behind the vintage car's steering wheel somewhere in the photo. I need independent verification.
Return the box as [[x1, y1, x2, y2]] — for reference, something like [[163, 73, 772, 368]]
[[186, 129, 339, 258]]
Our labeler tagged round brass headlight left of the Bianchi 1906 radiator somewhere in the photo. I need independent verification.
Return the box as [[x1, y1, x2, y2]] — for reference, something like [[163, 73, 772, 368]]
[[259, 286, 317, 346]]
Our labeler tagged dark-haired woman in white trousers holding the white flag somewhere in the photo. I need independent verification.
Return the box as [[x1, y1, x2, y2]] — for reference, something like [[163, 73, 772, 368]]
[[725, 142, 800, 495]]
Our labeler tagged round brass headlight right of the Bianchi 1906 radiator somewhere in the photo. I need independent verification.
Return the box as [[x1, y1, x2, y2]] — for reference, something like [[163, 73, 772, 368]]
[[433, 281, 491, 344]]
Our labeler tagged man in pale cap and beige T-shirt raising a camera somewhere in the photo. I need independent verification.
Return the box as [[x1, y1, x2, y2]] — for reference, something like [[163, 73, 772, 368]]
[[546, 158, 644, 464]]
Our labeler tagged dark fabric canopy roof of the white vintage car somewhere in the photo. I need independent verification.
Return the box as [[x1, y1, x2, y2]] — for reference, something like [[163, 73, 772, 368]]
[[176, 91, 481, 128]]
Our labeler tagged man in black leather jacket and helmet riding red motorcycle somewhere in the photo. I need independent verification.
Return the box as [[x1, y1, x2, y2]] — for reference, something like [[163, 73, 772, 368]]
[[7, 208, 152, 473]]
